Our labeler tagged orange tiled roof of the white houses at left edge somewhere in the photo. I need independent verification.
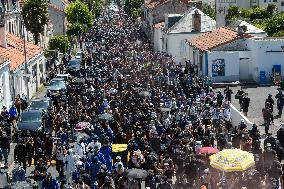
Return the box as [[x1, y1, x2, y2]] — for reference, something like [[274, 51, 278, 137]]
[[0, 33, 42, 70]]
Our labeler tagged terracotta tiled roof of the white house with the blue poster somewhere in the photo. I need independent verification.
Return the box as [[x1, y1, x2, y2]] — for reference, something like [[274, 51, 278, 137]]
[[187, 27, 252, 51]]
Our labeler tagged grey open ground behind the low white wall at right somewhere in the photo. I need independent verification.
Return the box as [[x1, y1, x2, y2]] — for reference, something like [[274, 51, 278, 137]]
[[217, 86, 284, 136]]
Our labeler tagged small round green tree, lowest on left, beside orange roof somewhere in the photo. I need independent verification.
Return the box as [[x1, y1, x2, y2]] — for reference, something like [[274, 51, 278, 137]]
[[48, 35, 71, 53]]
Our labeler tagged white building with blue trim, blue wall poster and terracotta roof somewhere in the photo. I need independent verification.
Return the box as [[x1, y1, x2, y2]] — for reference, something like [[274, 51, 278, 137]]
[[188, 27, 284, 83]]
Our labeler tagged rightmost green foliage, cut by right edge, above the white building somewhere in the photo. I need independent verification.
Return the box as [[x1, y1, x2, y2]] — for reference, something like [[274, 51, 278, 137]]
[[265, 13, 284, 36]]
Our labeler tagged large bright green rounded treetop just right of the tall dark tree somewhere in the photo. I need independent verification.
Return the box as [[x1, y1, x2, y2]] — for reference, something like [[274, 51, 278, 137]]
[[66, 0, 94, 27]]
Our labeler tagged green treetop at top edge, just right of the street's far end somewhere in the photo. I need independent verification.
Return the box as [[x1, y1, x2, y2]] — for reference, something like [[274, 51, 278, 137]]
[[124, 0, 144, 18]]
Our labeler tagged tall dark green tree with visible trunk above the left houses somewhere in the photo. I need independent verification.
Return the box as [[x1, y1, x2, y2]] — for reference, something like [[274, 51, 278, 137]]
[[23, 0, 48, 45]]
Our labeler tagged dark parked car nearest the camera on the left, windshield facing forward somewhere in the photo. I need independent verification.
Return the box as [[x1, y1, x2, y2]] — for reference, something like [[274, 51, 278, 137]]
[[17, 110, 44, 132]]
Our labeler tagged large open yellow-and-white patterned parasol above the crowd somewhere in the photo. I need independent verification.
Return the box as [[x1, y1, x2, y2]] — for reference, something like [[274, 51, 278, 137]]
[[210, 149, 255, 172]]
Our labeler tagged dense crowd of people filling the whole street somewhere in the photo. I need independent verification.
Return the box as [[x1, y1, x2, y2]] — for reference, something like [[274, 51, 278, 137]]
[[0, 1, 284, 189]]
